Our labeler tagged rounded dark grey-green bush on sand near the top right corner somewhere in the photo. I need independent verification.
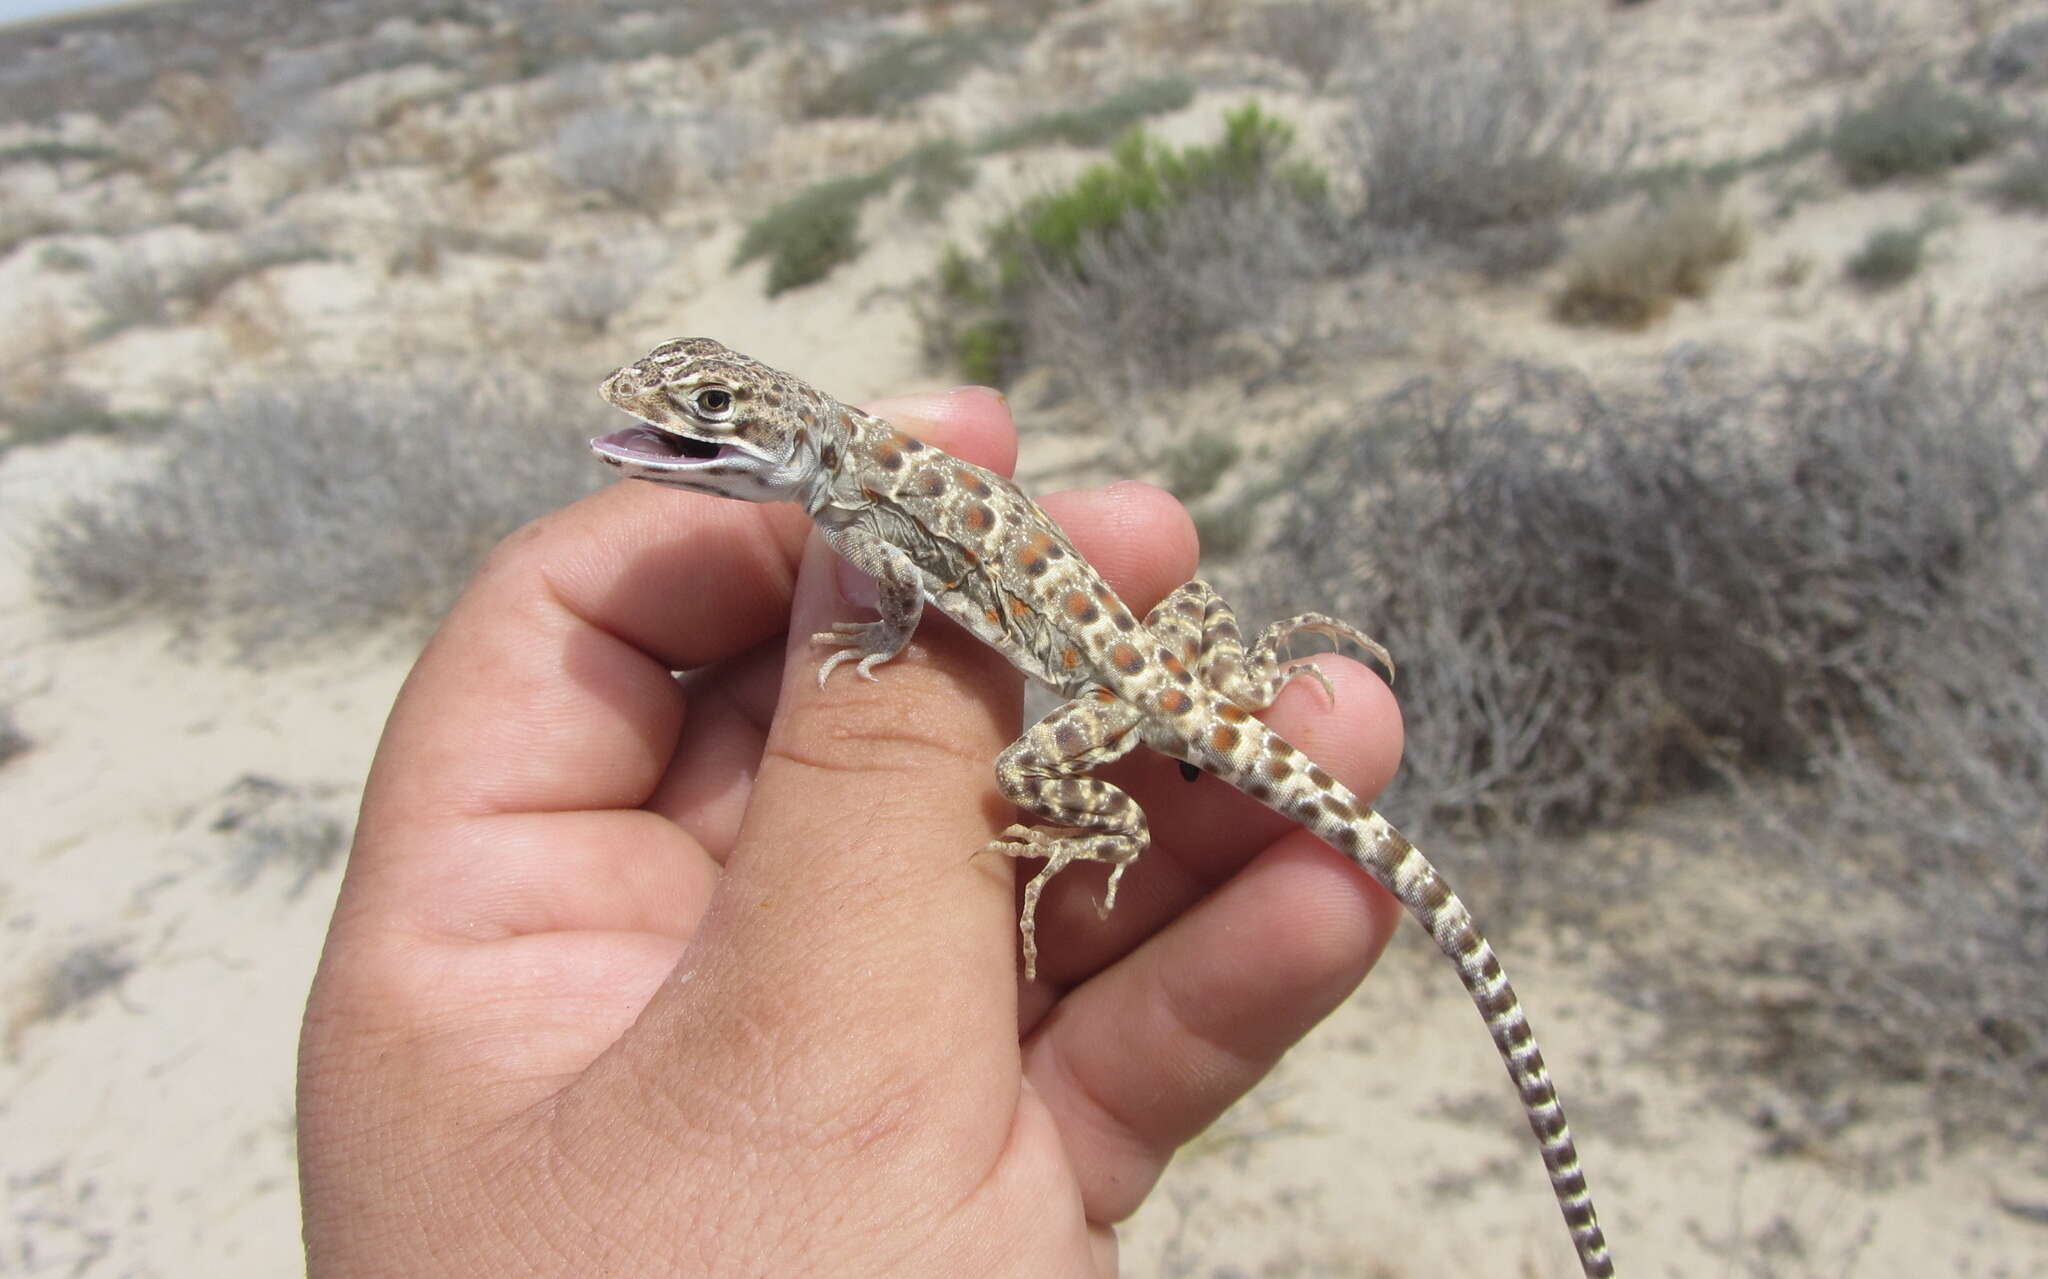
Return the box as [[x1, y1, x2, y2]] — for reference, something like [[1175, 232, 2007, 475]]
[[1827, 72, 2011, 186]]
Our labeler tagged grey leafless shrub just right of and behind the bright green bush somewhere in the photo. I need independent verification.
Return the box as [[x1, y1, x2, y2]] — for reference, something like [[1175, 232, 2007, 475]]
[[1350, 6, 1628, 270]]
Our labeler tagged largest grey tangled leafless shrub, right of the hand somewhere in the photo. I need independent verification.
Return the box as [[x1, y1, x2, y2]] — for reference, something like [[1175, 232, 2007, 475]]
[[1253, 327, 2048, 1123]]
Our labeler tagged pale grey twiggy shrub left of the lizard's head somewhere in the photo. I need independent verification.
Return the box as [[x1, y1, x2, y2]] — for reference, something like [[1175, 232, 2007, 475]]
[[35, 370, 600, 651]]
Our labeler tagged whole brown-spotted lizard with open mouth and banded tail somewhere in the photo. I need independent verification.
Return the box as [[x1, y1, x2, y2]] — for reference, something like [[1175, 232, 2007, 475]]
[[590, 338, 1614, 1279]]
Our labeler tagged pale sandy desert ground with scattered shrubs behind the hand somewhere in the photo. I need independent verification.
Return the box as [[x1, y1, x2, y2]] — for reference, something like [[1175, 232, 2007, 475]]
[[0, 0, 2048, 1279]]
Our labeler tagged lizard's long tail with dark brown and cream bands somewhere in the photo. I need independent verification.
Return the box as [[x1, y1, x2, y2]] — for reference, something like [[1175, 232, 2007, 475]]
[[1247, 729, 1614, 1279]]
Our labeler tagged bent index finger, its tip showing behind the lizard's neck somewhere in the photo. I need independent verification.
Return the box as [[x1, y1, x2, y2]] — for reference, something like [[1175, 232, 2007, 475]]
[[365, 391, 1016, 821]]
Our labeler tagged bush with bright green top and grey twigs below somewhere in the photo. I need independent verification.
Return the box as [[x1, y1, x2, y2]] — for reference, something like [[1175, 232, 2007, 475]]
[[926, 106, 1346, 388]]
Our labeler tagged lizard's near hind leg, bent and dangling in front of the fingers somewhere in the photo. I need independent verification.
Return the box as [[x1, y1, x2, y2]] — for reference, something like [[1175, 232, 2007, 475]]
[[987, 690, 1151, 980]]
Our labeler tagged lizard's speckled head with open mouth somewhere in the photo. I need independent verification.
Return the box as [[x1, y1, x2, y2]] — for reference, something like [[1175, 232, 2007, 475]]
[[590, 338, 829, 501]]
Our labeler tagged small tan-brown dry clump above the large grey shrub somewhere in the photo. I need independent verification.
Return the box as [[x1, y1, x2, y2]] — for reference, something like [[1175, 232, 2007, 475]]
[[1552, 186, 1749, 329]]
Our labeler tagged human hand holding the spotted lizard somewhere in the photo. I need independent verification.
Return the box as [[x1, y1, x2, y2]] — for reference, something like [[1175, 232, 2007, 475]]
[[299, 391, 1399, 1279]]
